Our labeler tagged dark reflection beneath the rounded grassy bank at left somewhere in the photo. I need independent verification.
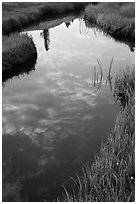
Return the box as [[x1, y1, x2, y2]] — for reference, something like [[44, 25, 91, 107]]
[[2, 58, 37, 87]]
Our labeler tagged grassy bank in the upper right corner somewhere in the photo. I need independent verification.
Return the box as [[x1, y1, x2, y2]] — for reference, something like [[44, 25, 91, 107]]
[[84, 2, 135, 42]]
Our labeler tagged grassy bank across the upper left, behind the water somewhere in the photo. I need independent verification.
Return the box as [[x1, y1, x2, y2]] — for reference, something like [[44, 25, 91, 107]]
[[2, 2, 87, 35]]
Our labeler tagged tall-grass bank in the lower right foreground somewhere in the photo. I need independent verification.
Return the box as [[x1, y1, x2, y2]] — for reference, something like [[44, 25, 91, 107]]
[[63, 69, 135, 202]]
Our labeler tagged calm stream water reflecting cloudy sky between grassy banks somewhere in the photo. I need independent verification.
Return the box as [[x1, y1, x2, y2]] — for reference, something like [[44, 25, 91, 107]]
[[2, 16, 134, 201]]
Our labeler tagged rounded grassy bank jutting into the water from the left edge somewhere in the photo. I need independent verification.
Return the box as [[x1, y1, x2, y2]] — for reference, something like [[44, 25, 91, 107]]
[[2, 35, 37, 72]]
